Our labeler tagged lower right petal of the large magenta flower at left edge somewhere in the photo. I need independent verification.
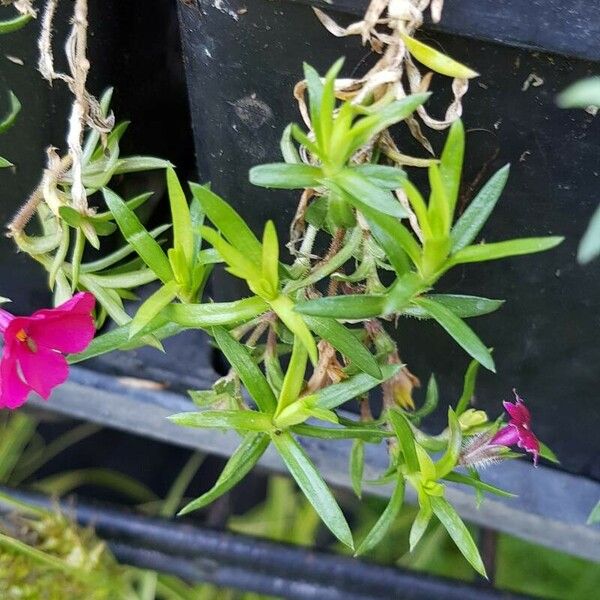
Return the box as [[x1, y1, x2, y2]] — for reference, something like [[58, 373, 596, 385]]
[[17, 347, 69, 400]]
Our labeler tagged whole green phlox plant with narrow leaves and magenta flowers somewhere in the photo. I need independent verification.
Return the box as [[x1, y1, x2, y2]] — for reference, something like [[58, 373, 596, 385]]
[[0, 45, 562, 574]]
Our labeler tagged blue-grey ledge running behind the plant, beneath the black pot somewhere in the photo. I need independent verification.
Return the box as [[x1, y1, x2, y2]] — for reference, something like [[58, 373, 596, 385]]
[[31, 365, 600, 561]]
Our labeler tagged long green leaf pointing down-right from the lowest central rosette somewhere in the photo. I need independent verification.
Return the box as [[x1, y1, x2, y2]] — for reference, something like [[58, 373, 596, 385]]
[[271, 432, 354, 548]]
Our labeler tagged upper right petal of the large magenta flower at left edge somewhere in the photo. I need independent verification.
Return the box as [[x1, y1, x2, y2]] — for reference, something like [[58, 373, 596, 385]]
[[27, 313, 96, 353]]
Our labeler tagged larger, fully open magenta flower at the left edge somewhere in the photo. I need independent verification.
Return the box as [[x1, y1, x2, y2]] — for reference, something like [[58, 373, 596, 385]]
[[0, 292, 96, 408]]
